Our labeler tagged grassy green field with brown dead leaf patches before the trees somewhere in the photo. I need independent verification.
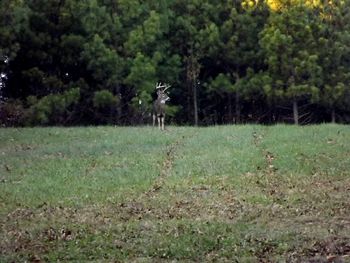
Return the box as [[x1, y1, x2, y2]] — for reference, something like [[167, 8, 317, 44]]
[[0, 125, 350, 262]]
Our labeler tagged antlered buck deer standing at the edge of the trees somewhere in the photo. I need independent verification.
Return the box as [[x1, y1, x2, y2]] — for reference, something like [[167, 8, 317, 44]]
[[152, 82, 171, 131]]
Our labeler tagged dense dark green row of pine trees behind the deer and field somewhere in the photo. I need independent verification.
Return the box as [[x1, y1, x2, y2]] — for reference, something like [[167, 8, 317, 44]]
[[0, 0, 350, 126]]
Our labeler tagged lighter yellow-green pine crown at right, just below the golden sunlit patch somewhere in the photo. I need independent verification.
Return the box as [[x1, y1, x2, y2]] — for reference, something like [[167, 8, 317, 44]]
[[261, 5, 322, 102]]
